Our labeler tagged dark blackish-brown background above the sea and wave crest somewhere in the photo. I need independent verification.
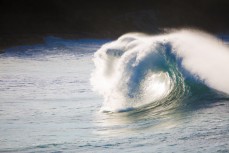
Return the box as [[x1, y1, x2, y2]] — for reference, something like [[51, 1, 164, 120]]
[[0, 0, 229, 48]]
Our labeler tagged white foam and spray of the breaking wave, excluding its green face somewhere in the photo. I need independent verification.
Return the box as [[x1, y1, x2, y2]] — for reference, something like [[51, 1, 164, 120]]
[[91, 30, 229, 111]]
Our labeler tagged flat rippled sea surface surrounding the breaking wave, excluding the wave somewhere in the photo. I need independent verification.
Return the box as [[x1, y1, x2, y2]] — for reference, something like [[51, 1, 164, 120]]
[[0, 32, 229, 153]]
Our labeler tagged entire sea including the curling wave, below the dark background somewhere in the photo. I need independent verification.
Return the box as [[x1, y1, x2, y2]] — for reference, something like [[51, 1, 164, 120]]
[[0, 30, 229, 153]]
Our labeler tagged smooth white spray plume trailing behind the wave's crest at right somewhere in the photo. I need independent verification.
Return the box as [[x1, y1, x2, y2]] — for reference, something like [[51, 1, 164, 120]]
[[169, 30, 229, 94]]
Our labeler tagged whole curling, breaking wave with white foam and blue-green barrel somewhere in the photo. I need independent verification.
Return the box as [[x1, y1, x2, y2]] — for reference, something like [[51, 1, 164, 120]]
[[91, 30, 229, 112]]
